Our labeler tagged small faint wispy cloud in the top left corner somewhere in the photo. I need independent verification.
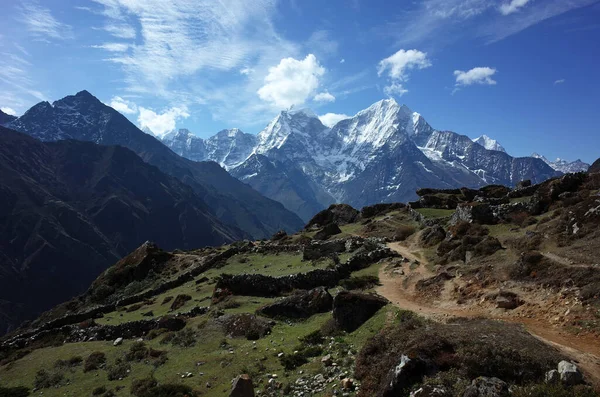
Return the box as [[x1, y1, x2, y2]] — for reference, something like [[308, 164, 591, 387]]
[[19, 2, 73, 40]]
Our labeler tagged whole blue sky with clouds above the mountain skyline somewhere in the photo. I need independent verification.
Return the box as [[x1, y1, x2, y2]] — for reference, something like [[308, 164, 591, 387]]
[[0, 0, 600, 162]]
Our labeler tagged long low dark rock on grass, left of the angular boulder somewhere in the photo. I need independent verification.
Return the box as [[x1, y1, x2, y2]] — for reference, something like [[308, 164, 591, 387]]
[[257, 287, 333, 318]]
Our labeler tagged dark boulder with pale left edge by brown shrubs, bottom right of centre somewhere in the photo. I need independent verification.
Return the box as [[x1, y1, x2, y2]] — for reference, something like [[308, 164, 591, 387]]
[[382, 354, 430, 397]]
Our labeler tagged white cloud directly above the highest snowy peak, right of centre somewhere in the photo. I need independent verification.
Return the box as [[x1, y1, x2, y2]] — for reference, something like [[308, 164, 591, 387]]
[[377, 50, 431, 96]]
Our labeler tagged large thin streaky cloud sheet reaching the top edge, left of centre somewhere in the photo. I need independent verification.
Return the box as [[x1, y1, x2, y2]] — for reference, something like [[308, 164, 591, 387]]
[[86, 0, 304, 123]]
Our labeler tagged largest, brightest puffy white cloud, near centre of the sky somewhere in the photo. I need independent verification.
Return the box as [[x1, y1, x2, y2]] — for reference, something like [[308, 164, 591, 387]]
[[257, 54, 325, 108]]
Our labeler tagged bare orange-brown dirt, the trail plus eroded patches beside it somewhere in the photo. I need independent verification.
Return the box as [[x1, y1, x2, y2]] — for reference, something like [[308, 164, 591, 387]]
[[377, 238, 600, 389]]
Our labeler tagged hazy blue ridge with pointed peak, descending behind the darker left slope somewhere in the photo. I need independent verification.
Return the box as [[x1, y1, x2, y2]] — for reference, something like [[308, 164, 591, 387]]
[[10, 91, 303, 238]]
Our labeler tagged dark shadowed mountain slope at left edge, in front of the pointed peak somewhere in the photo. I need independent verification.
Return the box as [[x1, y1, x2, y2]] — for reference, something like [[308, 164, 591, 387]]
[[0, 127, 248, 332]]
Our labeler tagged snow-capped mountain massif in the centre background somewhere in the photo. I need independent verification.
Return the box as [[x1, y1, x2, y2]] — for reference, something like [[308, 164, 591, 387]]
[[163, 99, 558, 220]]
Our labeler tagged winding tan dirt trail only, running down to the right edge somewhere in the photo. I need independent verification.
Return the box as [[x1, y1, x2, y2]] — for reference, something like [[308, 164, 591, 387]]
[[377, 243, 600, 389]]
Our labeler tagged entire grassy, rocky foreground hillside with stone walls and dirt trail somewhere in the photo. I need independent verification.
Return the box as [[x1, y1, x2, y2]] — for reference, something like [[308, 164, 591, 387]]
[[0, 174, 600, 397]]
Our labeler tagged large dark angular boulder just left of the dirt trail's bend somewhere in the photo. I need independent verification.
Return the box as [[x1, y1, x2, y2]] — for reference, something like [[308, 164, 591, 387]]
[[333, 291, 389, 332]]
